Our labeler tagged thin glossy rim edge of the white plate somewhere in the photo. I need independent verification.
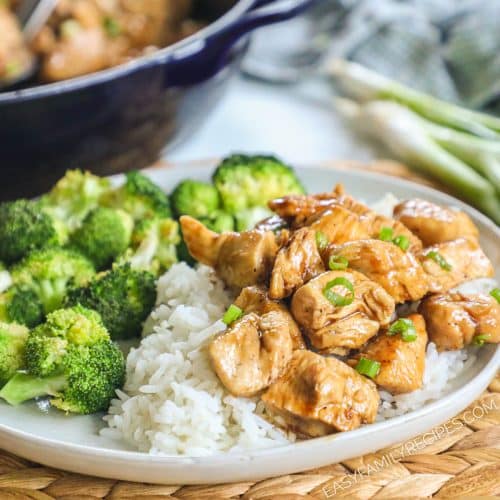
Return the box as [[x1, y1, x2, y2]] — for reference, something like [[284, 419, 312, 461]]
[[0, 160, 500, 468]]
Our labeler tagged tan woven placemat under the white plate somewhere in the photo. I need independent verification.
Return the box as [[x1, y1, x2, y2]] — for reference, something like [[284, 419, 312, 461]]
[[0, 162, 500, 500]]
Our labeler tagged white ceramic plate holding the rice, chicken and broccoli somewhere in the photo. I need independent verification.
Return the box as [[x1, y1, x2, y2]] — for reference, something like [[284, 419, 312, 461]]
[[0, 167, 500, 484]]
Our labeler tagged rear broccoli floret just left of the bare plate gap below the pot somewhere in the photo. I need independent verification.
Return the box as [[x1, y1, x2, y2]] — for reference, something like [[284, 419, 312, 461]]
[[101, 171, 172, 221]]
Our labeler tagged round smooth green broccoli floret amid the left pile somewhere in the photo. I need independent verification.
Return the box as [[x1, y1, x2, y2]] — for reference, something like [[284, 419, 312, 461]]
[[71, 207, 134, 270]]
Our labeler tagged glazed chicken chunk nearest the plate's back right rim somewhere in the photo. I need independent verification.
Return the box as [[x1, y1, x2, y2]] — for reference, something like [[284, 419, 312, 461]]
[[394, 199, 479, 246]]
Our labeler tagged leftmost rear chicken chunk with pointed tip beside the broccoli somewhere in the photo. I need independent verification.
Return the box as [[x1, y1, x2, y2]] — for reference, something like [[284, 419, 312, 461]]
[[180, 216, 278, 288]]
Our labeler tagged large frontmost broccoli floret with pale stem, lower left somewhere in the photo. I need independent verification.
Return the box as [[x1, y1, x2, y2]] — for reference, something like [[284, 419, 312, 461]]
[[0, 306, 125, 414]]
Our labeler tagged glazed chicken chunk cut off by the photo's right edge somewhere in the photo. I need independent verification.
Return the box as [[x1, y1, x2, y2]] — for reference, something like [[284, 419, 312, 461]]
[[419, 293, 500, 351]]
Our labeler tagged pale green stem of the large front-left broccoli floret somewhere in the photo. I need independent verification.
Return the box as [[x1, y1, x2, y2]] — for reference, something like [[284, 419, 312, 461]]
[[0, 372, 67, 406]]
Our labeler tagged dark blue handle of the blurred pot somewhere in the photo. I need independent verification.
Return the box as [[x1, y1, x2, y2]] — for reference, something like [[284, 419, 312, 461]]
[[161, 0, 321, 86]]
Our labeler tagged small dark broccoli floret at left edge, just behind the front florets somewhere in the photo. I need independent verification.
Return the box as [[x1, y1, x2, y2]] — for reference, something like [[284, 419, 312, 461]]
[[0, 285, 45, 328]]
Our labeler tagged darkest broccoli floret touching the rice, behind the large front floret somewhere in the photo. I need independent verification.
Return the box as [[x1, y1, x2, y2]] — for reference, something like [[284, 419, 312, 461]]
[[66, 264, 156, 340]]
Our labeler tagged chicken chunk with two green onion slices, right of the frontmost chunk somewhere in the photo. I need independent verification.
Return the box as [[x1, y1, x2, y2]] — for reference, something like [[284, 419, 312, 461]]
[[352, 314, 428, 394]]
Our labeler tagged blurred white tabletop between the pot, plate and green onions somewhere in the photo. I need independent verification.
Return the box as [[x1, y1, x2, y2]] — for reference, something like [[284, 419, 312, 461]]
[[165, 76, 373, 164]]
